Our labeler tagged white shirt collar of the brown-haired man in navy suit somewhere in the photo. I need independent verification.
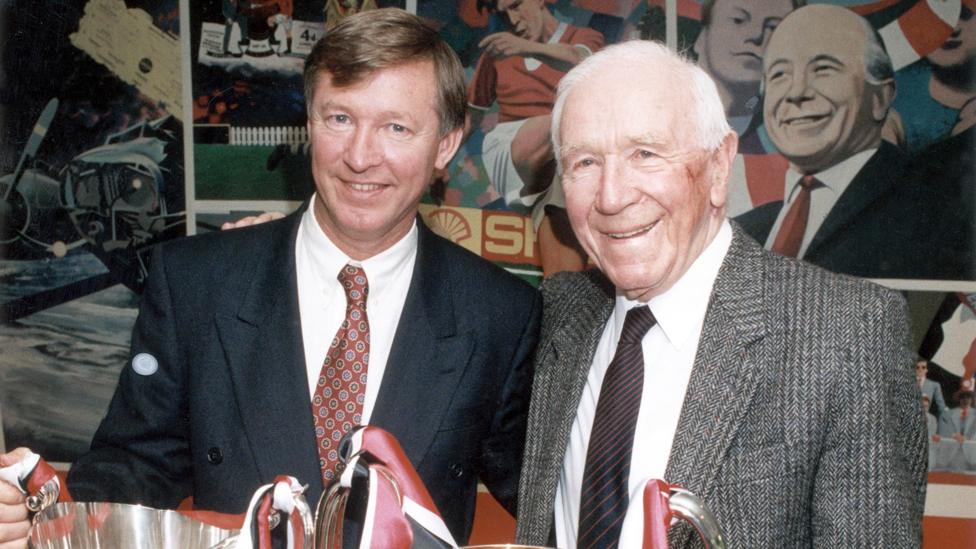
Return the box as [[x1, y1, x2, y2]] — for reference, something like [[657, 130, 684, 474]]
[[299, 196, 419, 288]]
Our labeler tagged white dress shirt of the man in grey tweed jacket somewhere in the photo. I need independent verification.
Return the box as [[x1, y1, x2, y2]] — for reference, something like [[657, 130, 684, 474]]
[[555, 221, 732, 549]]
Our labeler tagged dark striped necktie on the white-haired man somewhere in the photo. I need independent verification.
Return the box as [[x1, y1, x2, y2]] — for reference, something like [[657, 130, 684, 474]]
[[576, 306, 655, 549]]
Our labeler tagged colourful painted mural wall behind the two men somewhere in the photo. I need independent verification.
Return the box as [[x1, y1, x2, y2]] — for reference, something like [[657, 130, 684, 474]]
[[0, 0, 976, 536]]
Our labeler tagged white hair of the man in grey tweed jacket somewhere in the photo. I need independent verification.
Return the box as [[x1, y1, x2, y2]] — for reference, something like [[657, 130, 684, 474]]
[[551, 40, 732, 173]]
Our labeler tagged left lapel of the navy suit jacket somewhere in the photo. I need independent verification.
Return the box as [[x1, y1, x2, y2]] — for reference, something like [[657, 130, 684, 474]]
[[215, 207, 321, 501]]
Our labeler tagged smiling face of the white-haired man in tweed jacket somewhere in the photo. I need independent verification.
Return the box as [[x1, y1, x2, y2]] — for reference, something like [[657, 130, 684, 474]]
[[559, 66, 735, 301]]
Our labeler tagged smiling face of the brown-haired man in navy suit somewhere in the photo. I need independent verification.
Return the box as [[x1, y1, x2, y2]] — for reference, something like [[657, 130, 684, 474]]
[[308, 61, 461, 259]]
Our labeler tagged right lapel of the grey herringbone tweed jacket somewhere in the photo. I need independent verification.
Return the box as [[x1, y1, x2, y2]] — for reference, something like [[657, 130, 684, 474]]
[[665, 226, 766, 496]]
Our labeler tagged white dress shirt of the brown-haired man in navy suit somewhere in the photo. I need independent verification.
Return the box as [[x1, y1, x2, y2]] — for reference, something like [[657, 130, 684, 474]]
[[295, 197, 418, 424]]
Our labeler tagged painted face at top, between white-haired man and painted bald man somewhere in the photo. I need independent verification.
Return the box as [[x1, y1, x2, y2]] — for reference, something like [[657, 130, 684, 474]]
[[695, 0, 793, 93]]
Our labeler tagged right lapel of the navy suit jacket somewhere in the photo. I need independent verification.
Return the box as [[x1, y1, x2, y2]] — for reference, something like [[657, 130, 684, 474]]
[[370, 218, 473, 465]]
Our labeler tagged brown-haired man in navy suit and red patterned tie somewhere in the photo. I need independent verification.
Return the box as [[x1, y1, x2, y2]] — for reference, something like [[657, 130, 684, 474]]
[[0, 10, 539, 545]]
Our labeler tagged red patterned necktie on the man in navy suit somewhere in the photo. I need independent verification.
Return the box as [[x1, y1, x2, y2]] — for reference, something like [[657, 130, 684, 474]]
[[312, 265, 369, 483]]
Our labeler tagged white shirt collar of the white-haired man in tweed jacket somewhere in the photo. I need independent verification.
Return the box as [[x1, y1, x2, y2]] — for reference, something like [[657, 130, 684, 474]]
[[614, 219, 732, 350]]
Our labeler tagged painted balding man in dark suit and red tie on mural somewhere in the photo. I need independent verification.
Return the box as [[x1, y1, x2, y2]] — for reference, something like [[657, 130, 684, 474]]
[[737, 5, 960, 278]]
